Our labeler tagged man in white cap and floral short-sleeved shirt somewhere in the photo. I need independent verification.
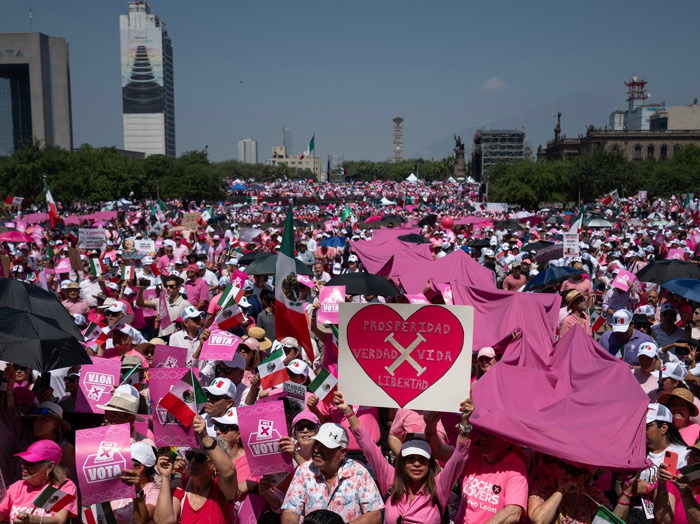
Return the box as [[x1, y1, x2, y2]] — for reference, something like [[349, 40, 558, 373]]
[[282, 422, 384, 524]]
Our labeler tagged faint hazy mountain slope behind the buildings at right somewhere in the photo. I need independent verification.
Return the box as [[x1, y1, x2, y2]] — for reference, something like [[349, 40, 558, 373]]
[[407, 91, 621, 159]]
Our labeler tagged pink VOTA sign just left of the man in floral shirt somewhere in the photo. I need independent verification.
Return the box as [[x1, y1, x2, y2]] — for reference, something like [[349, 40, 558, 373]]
[[237, 401, 294, 477]]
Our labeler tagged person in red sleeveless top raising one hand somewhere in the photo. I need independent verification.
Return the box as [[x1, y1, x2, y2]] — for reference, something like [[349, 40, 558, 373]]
[[153, 415, 238, 524]]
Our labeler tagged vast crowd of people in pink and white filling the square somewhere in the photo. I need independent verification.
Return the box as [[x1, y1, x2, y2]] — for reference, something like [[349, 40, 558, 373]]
[[0, 181, 700, 524]]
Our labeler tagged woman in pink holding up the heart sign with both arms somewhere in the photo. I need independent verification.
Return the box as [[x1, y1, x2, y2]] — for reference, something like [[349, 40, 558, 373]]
[[333, 392, 474, 524]]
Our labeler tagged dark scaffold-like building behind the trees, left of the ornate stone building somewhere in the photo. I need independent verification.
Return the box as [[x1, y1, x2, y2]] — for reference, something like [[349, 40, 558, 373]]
[[472, 128, 525, 181]]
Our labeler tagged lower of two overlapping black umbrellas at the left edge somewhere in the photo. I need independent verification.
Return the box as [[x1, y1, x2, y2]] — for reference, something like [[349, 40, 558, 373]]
[[0, 306, 92, 372]]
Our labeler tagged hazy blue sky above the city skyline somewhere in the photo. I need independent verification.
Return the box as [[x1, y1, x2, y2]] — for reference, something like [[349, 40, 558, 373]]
[[0, 0, 700, 162]]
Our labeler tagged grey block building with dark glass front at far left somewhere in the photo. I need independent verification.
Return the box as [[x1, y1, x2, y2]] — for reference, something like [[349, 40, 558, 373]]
[[0, 33, 73, 155]]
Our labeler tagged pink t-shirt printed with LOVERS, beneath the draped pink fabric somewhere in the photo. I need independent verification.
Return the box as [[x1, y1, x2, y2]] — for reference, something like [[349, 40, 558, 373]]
[[455, 446, 528, 524]]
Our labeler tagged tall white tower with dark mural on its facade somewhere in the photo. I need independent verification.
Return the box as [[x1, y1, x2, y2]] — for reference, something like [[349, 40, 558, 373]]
[[119, 0, 175, 157]]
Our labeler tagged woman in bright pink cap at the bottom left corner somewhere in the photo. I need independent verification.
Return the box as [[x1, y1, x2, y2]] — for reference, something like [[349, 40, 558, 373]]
[[0, 440, 78, 524]]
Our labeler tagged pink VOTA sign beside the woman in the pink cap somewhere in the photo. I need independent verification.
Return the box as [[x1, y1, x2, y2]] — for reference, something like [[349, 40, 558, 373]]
[[75, 424, 134, 506]]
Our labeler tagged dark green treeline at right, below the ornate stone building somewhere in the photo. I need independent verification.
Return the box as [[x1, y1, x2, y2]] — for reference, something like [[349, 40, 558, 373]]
[[488, 146, 700, 208]]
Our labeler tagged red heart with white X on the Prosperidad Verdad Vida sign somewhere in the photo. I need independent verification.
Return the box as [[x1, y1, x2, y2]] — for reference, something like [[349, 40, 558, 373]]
[[347, 305, 469, 408]]
